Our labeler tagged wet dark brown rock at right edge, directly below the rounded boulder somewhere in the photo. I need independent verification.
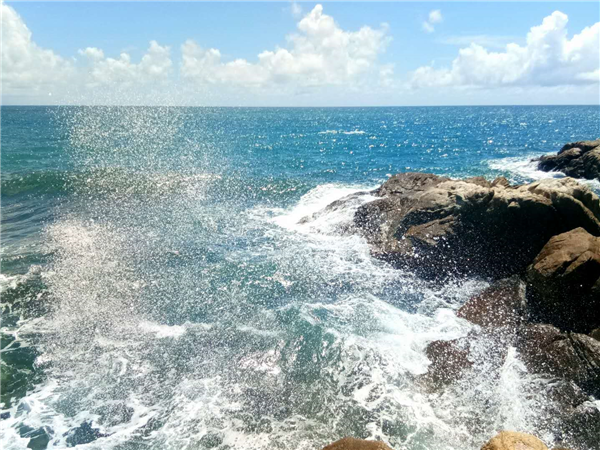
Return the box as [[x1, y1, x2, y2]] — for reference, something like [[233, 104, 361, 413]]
[[517, 324, 600, 397]]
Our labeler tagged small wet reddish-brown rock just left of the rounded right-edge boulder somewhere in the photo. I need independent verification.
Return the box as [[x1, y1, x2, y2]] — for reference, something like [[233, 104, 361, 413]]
[[456, 276, 526, 330]]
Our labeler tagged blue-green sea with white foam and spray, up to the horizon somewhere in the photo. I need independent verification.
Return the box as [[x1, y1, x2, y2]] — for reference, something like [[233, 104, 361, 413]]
[[0, 106, 600, 450]]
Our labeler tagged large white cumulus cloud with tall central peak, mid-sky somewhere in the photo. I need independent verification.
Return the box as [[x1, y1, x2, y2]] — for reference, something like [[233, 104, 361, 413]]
[[181, 5, 391, 87]]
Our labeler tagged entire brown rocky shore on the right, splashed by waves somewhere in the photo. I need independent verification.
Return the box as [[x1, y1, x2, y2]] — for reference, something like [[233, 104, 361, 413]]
[[304, 141, 600, 450]]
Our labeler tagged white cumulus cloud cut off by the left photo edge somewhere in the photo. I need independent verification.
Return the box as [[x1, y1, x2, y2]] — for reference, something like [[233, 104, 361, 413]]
[[0, 3, 75, 95]]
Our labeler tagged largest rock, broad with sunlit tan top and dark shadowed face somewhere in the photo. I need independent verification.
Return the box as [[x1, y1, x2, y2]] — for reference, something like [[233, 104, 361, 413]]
[[354, 173, 600, 279]]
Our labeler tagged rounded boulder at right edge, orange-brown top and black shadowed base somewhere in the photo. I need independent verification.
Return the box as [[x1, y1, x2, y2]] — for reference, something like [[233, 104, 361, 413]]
[[527, 228, 600, 333]]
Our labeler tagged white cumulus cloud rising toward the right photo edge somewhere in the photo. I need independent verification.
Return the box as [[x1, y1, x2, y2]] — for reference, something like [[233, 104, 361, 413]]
[[411, 11, 600, 87]]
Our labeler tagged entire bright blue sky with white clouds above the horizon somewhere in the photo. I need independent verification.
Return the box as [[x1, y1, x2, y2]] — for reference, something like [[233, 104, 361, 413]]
[[1, 1, 600, 106]]
